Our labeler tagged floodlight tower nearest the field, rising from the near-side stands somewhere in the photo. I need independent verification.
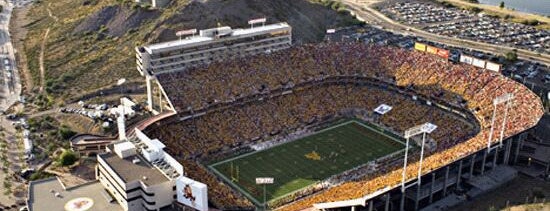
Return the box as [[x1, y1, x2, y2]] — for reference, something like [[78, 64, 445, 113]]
[[400, 122, 437, 211]]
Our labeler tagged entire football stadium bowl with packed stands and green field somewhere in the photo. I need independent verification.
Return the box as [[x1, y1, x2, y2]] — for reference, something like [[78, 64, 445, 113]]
[[143, 42, 543, 210]]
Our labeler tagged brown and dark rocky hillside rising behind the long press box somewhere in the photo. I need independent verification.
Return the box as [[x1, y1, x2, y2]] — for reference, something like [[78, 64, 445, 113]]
[[23, 0, 357, 104]]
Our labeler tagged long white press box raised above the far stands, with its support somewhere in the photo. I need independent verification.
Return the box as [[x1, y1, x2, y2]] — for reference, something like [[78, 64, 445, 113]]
[[136, 23, 292, 113]]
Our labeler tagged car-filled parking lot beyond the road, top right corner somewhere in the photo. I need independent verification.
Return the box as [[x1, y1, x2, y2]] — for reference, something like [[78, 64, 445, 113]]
[[381, 2, 550, 53]]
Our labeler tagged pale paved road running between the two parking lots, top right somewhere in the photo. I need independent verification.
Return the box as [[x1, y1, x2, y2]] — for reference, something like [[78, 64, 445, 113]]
[[342, 0, 550, 66]]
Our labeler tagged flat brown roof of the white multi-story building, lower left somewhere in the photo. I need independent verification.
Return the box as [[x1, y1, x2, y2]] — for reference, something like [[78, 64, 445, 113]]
[[99, 153, 169, 186]]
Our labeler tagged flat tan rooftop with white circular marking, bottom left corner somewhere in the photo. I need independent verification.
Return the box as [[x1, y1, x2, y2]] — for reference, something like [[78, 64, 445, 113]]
[[28, 177, 122, 211]]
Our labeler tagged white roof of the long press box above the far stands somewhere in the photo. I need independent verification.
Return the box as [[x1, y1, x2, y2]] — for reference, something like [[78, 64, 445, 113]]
[[144, 23, 290, 53]]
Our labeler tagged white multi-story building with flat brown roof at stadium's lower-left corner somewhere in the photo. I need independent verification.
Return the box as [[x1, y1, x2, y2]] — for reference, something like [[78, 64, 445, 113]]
[[96, 131, 198, 211]]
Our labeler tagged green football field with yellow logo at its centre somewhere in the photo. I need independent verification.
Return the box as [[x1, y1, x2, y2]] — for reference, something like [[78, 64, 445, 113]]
[[210, 120, 404, 204]]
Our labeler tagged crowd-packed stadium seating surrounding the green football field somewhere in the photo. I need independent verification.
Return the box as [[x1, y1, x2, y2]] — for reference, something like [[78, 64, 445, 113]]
[[146, 43, 543, 210]]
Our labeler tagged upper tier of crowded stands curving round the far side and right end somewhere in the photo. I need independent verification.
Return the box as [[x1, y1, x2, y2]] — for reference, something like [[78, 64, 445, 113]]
[[144, 43, 544, 210]]
